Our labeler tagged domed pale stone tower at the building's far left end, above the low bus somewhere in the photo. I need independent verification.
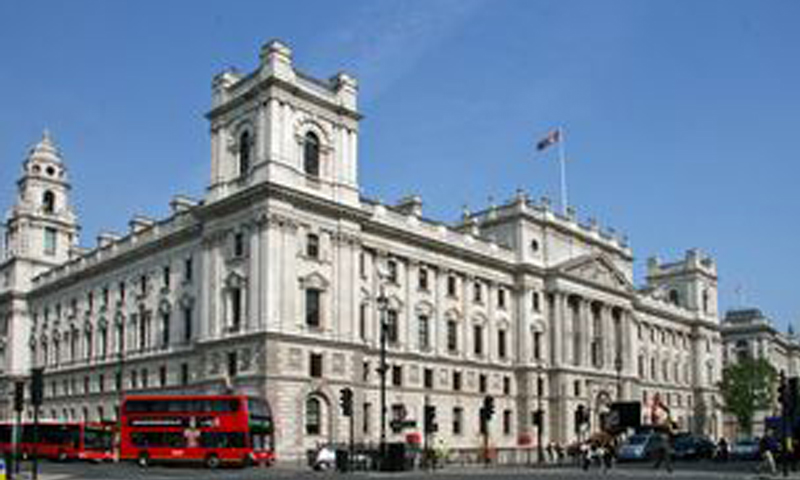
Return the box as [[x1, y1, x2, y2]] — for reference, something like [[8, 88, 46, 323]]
[[0, 131, 80, 386]]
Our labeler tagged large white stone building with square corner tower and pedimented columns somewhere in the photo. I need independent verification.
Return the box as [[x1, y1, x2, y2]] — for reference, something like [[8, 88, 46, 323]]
[[0, 41, 721, 458]]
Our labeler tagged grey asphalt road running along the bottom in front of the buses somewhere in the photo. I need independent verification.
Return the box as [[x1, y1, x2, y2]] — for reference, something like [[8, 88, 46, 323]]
[[1, 461, 788, 480]]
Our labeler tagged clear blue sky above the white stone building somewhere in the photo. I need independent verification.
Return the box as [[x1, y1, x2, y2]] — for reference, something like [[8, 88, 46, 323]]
[[0, 0, 800, 328]]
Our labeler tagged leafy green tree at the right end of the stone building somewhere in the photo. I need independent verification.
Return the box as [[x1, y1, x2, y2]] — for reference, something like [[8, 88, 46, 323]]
[[720, 357, 777, 434]]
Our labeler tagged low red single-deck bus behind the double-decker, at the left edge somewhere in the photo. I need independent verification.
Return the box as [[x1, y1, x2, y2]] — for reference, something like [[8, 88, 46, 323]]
[[0, 421, 114, 462]]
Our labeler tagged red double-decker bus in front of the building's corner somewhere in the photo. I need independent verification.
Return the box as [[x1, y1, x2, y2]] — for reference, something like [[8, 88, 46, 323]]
[[120, 395, 275, 468]]
